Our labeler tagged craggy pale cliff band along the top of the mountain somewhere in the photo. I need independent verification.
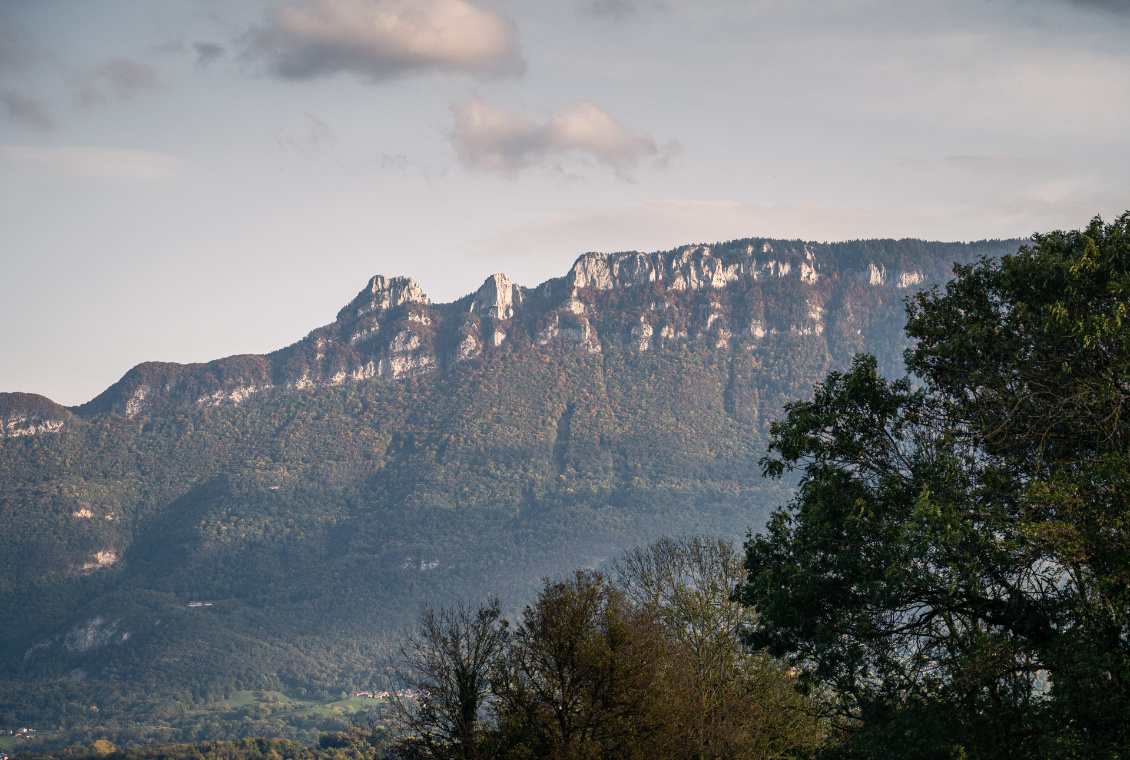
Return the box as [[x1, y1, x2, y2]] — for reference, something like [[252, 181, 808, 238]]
[[66, 233, 1017, 418]]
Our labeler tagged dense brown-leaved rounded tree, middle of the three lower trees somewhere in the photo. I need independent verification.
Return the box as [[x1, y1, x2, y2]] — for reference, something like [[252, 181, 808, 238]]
[[495, 570, 663, 760]]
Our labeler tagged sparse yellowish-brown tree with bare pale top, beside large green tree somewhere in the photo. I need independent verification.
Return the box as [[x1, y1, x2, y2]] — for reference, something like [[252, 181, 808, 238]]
[[616, 536, 823, 760]]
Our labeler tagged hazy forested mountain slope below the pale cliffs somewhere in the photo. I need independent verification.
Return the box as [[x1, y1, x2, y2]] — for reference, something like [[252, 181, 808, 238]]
[[0, 349, 779, 741]]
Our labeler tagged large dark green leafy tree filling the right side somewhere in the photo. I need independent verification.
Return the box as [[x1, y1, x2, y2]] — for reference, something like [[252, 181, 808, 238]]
[[741, 213, 1130, 758]]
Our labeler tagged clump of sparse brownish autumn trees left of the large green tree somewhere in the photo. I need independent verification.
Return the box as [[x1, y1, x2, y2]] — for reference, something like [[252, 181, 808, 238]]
[[390, 538, 825, 760]]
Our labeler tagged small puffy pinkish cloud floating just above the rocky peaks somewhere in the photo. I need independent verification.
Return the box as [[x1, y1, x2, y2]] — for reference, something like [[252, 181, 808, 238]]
[[452, 96, 679, 176]]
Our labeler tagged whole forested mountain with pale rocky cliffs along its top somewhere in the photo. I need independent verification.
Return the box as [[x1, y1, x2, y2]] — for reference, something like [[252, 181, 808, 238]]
[[0, 238, 1020, 742]]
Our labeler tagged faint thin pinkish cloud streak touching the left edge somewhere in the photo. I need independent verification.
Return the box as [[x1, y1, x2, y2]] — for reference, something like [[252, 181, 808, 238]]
[[0, 146, 183, 180]]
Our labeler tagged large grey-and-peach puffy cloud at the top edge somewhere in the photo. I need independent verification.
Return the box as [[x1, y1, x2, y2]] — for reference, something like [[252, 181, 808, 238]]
[[249, 0, 524, 79]]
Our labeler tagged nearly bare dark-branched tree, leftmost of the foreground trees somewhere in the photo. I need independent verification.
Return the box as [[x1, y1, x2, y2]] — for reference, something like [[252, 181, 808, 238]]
[[389, 599, 509, 760]]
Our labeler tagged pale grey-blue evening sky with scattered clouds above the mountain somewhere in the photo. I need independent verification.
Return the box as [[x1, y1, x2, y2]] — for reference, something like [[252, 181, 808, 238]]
[[0, 0, 1130, 404]]
